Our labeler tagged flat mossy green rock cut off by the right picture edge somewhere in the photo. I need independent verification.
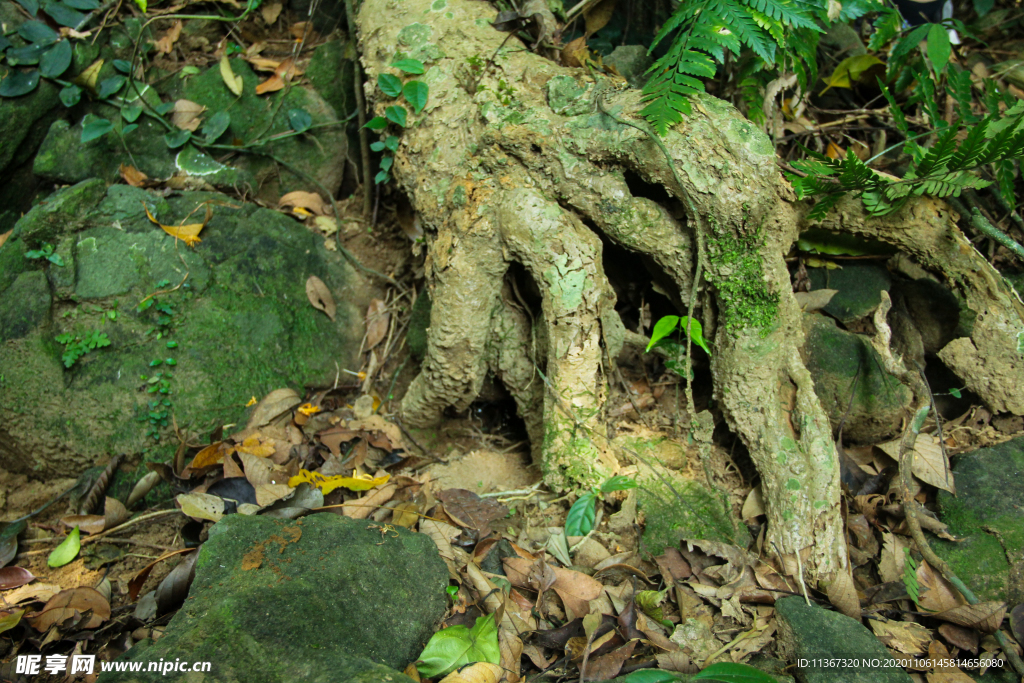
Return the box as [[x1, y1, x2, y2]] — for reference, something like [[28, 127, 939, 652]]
[[932, 437, 1024, 605]]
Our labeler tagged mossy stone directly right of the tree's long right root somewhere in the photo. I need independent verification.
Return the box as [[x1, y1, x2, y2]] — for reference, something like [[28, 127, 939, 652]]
[[803, 313, 911, 443]]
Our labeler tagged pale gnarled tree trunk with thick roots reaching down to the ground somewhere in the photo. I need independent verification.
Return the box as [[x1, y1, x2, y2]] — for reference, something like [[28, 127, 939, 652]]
[[359, 0, 1020, 611]]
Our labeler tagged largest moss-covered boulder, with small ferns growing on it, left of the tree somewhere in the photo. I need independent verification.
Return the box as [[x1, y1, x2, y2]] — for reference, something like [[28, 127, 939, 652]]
[[0, 180, 369, 475]]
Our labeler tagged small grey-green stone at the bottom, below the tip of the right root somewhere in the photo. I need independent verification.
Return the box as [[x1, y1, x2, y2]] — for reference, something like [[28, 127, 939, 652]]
[[775, 596, 910, 683]]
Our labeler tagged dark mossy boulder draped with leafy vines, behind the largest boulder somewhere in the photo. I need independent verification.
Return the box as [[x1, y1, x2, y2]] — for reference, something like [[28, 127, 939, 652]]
[[33, 58, 348, 202]]
